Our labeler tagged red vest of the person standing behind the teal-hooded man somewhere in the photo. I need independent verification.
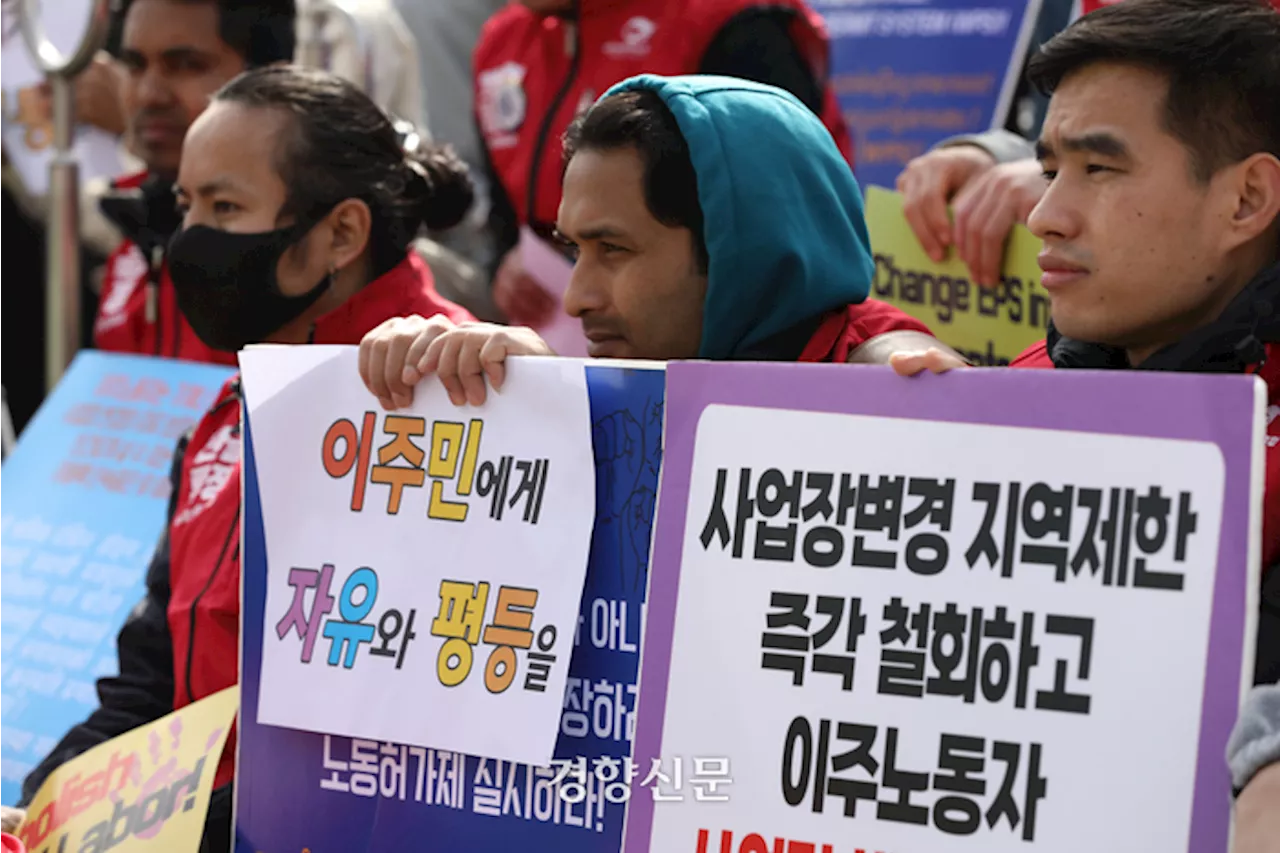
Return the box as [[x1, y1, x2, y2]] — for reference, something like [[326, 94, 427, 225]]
[[475, 0, 852, 233]]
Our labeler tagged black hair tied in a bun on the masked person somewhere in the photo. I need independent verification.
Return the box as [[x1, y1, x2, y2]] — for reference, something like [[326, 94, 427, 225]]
[[214, 65, 475, 274]]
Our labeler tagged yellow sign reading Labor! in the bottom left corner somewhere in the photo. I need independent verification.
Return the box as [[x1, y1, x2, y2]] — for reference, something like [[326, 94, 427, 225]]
[[17, 686, 239, 853]]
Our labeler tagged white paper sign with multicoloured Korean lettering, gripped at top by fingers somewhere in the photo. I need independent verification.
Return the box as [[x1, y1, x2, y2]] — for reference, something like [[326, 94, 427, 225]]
[[241, 346, 595, 766]]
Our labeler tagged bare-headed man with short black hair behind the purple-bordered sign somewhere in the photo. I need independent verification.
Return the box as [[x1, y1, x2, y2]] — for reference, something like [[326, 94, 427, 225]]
[[893, 0, 1280, 684]]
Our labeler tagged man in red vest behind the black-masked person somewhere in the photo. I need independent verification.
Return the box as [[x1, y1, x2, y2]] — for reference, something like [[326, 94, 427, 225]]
[[93, 0, 296, 365]]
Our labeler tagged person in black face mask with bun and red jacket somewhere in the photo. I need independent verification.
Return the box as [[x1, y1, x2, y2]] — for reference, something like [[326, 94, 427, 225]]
[[23, 67, 472, 852]]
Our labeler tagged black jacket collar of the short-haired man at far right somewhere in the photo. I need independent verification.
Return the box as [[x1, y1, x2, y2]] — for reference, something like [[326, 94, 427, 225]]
[[1044, 264, 1280, 373]]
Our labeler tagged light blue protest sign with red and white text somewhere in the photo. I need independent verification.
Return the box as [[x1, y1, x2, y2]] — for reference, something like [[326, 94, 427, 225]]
[[0, 351, 230, 803]]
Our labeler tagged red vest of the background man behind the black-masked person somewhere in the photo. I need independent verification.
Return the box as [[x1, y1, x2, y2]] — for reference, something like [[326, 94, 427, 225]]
[[93, 174, 236, 366]]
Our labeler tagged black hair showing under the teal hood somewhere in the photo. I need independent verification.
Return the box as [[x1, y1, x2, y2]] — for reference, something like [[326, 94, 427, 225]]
[[564, 90, 709, 273]]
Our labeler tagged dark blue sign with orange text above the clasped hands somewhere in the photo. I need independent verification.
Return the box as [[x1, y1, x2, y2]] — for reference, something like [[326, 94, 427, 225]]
[[812, 0, 1041, 187]]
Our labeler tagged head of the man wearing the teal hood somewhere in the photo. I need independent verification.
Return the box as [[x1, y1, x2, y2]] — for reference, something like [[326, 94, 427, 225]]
[[557, 74, 873, 360]]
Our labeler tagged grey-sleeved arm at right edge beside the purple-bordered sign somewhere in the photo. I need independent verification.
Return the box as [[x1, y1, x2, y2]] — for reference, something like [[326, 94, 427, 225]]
[[1228, 684, 1280, 853]]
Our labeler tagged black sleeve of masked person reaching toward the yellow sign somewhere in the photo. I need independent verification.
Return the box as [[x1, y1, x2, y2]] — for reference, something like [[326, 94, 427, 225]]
[[19, 435, 189, 808]]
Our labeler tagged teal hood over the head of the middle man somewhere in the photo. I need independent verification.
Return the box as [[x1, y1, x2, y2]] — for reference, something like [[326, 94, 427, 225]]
[[604, 74, 874, 360]]
